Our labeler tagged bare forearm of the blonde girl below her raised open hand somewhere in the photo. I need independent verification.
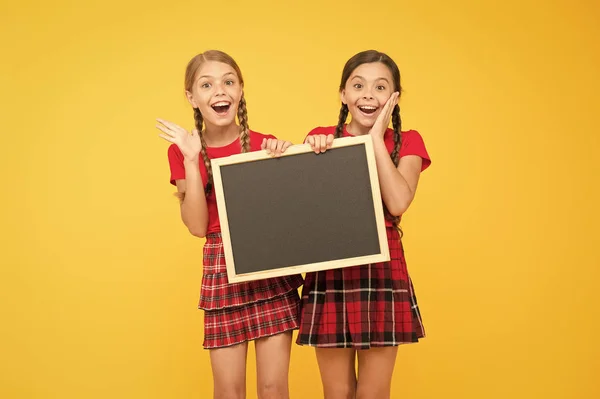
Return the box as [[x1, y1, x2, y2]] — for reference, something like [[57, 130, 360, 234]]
[[181, 160, 208, 237]]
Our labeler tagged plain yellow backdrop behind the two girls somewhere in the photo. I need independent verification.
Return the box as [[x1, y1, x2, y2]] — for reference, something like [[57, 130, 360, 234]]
[[0, 0, 600, 399]]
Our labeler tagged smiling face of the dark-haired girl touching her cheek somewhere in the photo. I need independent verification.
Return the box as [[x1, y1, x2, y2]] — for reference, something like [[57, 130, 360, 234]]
[[340, 62, 396, 132]]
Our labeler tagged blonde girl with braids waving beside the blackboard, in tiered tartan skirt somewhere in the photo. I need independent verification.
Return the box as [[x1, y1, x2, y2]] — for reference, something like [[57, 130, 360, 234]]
[[157, 50, 302, 399]]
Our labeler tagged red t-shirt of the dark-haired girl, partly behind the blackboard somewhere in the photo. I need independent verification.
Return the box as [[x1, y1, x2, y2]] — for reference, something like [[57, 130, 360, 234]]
[[305, 125, 431, 226]]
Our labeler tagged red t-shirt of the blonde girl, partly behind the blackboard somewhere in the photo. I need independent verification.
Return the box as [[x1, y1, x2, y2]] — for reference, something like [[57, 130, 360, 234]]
[[168, 130, 276, 233]]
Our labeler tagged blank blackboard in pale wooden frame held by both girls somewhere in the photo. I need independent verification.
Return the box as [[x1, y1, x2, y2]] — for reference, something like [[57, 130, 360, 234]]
[[212, 135, 389, 283]]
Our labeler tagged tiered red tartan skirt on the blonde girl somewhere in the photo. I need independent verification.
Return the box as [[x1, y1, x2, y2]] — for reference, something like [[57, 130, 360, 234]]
[[198, 233, 303, 349]]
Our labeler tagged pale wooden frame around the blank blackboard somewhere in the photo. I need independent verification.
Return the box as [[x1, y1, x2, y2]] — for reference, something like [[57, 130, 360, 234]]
[[211, 135, 390, 283]]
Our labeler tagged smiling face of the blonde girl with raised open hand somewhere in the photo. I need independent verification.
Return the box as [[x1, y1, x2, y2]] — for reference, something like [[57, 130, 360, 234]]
[[186, 61, 243, 127]]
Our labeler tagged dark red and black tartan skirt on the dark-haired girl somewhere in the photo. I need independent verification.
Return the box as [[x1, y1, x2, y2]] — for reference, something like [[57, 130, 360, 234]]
[[296, 227, 425, 349]]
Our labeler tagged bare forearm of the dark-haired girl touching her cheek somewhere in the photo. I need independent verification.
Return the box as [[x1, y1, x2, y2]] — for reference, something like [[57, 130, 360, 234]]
[[373, 137, 414, 216]]
